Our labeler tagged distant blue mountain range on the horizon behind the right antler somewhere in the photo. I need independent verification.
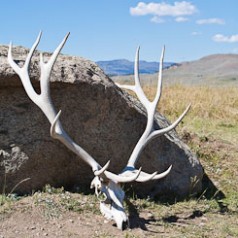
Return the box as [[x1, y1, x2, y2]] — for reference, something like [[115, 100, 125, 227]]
[[96, 59, 177, 76]]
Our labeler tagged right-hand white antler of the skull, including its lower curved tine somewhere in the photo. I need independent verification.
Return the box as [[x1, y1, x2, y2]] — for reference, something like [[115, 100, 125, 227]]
[[117, 47, 190, 182]]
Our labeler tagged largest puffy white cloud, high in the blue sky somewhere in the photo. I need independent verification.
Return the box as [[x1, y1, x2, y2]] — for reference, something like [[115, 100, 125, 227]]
[[130, 1, 197, 23]]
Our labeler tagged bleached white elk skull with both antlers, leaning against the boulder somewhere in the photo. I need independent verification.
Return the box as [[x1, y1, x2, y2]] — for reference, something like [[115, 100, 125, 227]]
[[8, 33, 190, 229]]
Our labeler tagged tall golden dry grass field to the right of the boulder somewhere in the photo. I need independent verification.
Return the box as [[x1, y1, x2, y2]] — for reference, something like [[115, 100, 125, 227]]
[[144, 85, 238, 143]]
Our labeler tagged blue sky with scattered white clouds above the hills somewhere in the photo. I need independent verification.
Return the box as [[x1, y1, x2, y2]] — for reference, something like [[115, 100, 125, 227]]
[[0, 0, 238, 62]]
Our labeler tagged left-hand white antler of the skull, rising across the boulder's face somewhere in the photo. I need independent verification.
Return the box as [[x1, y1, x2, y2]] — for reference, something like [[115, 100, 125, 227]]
[[8, 32, 140, 183]]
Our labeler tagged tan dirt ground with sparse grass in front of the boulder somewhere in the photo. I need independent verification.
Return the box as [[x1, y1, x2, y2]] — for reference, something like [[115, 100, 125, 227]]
[[0, 192, 238, 238]]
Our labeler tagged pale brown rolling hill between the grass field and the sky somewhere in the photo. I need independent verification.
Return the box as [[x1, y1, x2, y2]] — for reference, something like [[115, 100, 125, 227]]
[[112, 54, 238, 86]]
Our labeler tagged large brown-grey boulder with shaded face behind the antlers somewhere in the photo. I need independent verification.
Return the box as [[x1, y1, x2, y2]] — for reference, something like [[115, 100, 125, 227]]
[[0, 46, 203, 198]]
